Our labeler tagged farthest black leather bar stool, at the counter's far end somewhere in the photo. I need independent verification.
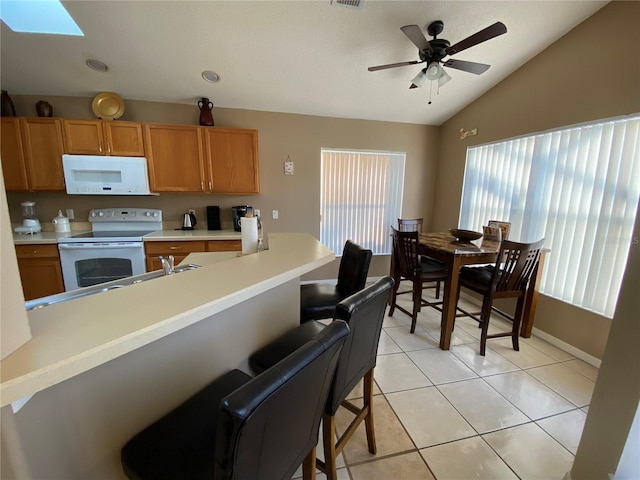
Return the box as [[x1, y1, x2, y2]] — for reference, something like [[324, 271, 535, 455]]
[[300, 240, 372, 323]]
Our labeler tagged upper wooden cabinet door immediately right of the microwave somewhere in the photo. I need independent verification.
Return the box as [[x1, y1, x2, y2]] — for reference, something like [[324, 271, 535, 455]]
[[144, 124, 205, 192]]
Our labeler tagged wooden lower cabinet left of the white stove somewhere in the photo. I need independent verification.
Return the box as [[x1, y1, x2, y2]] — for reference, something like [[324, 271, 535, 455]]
[[16, 245, 64, 300]]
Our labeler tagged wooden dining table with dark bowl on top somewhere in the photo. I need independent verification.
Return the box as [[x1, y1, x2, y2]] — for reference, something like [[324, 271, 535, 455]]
[[420, 232, 547, 350]]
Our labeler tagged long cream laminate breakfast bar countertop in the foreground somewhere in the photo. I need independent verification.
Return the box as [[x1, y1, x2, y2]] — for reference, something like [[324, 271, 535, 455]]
[[0, 233, 335, 406]]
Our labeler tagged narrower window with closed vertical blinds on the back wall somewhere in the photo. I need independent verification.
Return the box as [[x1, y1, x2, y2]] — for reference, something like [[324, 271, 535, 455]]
[[320, 149, 405, 256]]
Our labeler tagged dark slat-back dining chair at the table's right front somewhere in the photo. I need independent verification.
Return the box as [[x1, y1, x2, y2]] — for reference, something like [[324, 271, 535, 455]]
[[456, 238, 544, 356]]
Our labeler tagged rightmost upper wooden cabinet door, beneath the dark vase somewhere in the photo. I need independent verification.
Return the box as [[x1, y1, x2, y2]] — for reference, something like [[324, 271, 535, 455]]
[[204, 127, 260, 193]]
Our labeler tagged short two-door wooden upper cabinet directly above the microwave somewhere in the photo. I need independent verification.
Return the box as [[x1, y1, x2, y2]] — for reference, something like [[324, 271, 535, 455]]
[[63, 120, 145, 157]]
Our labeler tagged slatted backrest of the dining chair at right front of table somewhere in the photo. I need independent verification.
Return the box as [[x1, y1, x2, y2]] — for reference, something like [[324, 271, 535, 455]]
[[491, 238, 544, 292]]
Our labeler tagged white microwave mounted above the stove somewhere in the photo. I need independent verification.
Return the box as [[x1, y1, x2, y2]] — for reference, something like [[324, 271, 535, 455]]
[[62, 155, 153, 195]]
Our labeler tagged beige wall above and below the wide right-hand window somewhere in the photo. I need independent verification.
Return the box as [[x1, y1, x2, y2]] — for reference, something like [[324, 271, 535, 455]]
[[429, 2, 640, 358]]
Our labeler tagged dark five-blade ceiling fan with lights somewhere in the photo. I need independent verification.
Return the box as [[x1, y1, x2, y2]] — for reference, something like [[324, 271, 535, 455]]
[[368, 20, 507, 96]]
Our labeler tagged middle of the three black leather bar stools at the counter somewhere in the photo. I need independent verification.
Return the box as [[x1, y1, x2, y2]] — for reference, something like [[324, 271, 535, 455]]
[[249, 276, 393, 480]]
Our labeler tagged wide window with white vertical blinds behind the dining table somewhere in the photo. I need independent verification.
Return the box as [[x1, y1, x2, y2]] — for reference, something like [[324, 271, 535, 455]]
[[460, 115, 640, 317]]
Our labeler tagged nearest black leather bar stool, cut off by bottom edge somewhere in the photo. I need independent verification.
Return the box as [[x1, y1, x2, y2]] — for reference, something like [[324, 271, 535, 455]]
[[121, 321, 349, 480]]
